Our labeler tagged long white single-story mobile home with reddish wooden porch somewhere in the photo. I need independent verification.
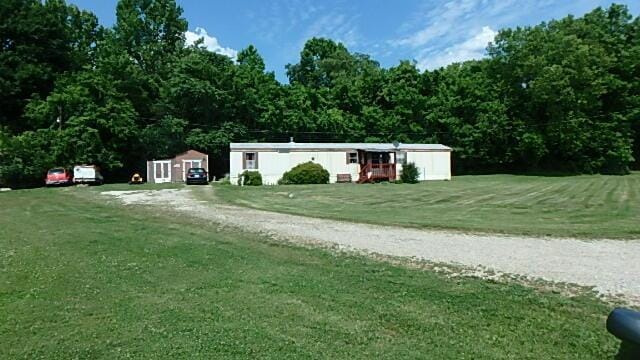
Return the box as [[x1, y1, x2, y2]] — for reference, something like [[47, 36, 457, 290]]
[[229, 142, 451, 185]]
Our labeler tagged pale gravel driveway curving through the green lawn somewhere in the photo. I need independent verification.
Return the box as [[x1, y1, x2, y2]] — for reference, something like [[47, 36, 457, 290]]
[[102, 188, 640, 303]]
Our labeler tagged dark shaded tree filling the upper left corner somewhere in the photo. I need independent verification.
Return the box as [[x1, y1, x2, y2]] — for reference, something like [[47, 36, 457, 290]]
[[0, 0, 101, 133]]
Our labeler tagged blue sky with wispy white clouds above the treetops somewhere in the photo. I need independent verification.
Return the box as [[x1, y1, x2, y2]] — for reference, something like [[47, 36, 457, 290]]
[[70, 0, 640, 82]]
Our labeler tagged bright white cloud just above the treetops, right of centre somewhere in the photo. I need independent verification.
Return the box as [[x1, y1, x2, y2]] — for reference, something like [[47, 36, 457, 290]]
[[417, 26, 498, 70]]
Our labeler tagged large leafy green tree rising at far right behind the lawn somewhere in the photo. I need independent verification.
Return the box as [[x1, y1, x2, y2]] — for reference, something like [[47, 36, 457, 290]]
[[489, 5, 633, 173]]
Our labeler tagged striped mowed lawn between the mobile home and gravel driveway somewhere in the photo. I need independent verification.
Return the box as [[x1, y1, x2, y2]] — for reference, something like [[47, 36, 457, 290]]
[[216, 173, 640, 238]]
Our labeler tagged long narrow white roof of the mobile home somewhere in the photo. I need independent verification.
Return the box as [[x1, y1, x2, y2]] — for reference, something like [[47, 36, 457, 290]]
[[230, 142, 451, 151]]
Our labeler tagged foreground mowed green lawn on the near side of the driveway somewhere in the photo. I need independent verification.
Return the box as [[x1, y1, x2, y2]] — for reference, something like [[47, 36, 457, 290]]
[[0, 188, 618, 359]]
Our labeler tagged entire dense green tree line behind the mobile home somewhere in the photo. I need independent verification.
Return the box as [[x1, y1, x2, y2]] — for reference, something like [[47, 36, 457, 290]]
[[0, 0, 640, 185]]
